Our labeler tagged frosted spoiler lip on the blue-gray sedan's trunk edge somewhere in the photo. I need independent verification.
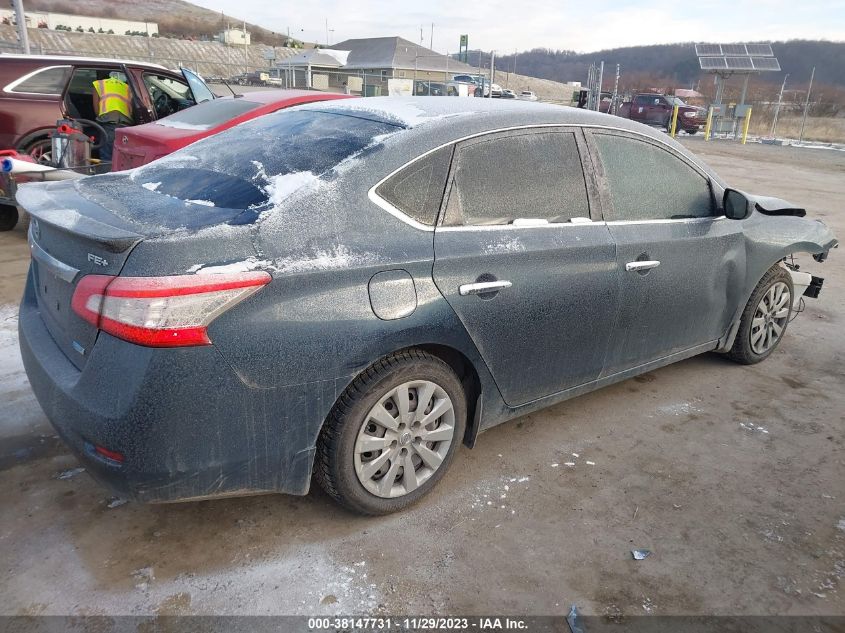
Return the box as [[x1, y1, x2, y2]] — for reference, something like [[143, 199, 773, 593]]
[[15, 181, 144, 253]]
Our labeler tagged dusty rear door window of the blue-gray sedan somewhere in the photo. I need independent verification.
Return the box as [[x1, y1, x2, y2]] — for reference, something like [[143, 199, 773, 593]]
[[443, 132, 589, 226]]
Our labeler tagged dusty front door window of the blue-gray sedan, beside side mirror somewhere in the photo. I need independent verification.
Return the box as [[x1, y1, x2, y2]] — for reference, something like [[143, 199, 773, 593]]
[[593, 134, 713, 221]]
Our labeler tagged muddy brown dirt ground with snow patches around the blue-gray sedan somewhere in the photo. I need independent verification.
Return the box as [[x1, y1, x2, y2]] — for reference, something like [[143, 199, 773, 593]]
[[0, 139, 845, 615]]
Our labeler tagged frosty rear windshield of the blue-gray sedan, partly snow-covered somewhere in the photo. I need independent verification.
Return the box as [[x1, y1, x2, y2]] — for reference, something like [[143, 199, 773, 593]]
[[129, 106, 401, 209]]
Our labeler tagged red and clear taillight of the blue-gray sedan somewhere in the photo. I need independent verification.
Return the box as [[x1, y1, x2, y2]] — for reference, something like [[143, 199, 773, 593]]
[[71, 272, 270, 347]]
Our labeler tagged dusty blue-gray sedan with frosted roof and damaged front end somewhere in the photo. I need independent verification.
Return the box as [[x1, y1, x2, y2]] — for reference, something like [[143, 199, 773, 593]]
[[18, 98, 837, 514]]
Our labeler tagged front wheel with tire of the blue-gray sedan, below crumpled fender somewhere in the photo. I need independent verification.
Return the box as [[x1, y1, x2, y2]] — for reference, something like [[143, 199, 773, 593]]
[[728, 265, 794, 365]]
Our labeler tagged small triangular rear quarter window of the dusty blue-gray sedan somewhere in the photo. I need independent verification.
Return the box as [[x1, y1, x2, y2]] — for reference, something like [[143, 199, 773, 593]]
[[376, 145, 452, 226]]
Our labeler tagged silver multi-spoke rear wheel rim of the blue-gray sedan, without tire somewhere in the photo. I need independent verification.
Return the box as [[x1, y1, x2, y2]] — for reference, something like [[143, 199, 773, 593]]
[[354, 380, 455, 498]]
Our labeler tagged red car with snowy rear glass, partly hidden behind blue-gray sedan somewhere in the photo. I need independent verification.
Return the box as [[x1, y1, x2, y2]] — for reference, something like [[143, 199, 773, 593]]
[[112, 90, 349, 171]]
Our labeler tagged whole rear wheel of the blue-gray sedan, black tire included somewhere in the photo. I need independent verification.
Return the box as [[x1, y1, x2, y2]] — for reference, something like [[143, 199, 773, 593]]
[[314, 349, 466, 515]]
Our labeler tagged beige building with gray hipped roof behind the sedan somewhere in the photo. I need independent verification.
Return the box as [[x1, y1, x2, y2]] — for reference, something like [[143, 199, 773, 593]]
[[277, 37, 477, 96]]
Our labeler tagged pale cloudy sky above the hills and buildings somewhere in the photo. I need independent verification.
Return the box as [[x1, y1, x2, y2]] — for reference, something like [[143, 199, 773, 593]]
[[191, 0, 845, 54]]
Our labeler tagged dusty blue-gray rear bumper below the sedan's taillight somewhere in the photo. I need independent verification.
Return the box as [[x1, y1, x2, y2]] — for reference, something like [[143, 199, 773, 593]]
[[18, 275, 336, 502]]
